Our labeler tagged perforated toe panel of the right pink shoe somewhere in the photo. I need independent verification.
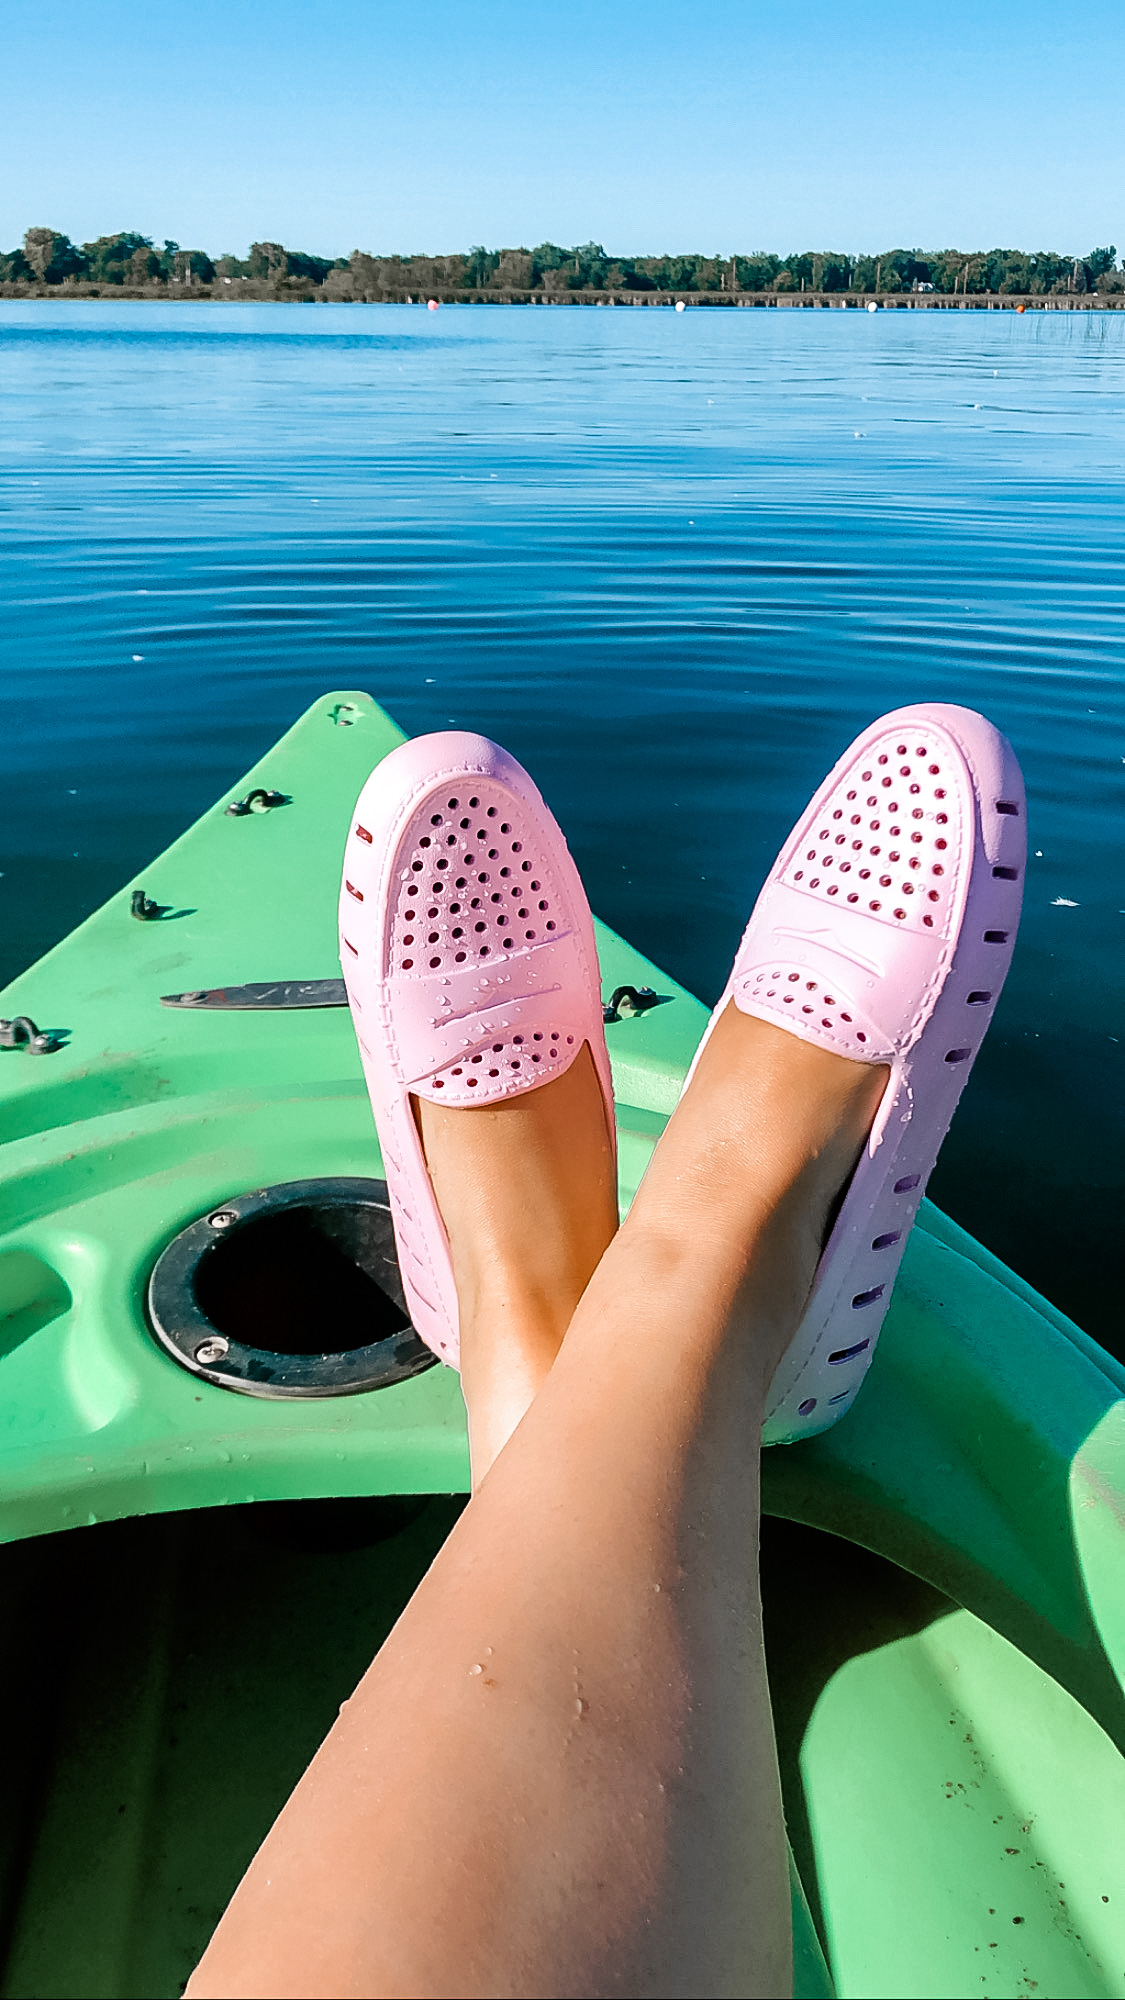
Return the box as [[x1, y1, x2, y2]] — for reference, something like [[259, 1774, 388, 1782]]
[[785, 738, 967, 930]]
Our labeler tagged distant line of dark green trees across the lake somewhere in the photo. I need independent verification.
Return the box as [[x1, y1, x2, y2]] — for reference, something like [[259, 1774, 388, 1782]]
[[0, 228, 1125, 298]]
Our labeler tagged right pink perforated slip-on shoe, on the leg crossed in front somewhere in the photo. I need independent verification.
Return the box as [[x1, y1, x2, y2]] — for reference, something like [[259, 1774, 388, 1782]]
[[684, 702, 1027, 1444]]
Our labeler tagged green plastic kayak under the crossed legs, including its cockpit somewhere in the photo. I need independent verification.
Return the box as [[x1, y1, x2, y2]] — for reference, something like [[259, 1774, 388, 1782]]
[[0, 692, 1125, 2000]]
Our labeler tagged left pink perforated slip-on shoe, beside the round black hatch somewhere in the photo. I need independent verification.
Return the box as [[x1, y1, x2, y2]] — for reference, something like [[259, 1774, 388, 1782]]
[[340, 730, 615, 1368]]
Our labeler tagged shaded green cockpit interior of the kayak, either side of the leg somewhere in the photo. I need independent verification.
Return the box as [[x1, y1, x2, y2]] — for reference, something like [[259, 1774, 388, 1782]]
[[0, 1498, 1125, 2000]]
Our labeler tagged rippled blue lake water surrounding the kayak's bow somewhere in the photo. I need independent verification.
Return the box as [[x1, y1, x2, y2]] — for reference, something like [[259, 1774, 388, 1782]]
[[0, 302, 1125, 1350]]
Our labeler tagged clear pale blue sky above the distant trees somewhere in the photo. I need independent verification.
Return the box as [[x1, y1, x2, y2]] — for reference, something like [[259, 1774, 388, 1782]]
[[0, 0, 1125, 256]]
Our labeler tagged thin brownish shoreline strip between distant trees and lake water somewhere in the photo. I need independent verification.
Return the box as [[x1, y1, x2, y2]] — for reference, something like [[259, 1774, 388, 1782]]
[[0, 282, 1125, 312]]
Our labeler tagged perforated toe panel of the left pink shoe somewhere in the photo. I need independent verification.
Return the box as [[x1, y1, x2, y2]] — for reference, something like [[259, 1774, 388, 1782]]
[[388, 780, 569, 972]]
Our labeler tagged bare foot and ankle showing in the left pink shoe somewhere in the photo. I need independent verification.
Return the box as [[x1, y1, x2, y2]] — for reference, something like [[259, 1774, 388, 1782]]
[[414, 1046, 617, 1486]]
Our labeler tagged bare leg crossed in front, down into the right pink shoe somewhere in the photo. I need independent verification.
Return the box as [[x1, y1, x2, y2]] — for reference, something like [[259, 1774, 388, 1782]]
[[188, 1010, 885, 2000]]
